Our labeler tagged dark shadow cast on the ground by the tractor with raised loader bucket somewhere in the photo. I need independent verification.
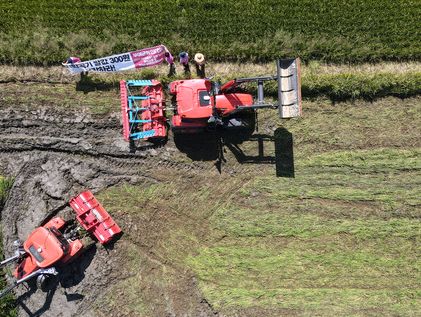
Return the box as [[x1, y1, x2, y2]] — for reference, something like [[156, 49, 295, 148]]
[[174, 128, 295, 178]]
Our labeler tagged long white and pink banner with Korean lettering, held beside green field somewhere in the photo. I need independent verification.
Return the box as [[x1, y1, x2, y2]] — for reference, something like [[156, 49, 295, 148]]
[[62, 45, 168, 74]]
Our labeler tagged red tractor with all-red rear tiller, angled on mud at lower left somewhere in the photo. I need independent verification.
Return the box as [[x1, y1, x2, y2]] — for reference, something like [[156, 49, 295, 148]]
[[0, 191, 121, 298]]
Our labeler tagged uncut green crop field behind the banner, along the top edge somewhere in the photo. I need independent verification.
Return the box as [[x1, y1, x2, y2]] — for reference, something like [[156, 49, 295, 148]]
[[0, 0, 421, 65]]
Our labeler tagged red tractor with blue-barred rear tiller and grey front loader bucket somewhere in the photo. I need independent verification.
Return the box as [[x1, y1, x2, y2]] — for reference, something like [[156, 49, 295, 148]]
[[120, 58, 301, 142]]
